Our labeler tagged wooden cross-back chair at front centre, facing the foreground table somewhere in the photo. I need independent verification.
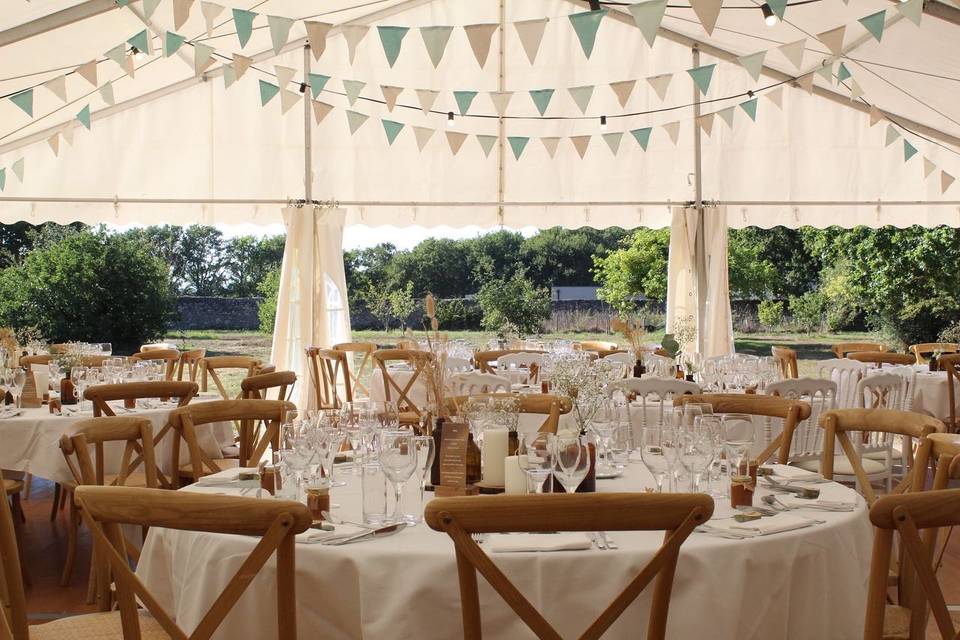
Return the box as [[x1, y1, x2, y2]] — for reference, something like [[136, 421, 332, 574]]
[[424, 493, 714, 640]]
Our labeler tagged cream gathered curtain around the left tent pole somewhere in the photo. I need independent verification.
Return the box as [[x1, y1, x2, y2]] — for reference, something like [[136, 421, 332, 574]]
[[271, 207, 350, 409]]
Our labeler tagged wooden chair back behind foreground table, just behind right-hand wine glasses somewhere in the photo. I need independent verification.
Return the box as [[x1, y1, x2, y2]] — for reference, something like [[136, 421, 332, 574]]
[[673, 393, 811, 464]]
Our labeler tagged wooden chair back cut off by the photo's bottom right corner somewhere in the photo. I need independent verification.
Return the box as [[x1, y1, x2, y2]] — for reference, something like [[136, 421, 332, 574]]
[[863, 489, 960, 640]]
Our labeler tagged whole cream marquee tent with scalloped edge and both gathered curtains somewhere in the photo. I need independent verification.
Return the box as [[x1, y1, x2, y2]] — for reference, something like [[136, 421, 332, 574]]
[[0, 0, 960, 402]]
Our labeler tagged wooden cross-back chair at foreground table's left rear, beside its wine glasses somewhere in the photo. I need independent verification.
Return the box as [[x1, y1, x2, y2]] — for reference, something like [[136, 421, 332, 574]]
[[168, 400, 296, 488]]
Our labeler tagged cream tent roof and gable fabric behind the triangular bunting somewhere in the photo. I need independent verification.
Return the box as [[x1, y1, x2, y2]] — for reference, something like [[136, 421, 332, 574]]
[[0, 0, 960, 227]]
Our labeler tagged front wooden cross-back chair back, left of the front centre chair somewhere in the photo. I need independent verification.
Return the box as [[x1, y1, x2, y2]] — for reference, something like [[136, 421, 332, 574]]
[[76, 487, 312, 640]]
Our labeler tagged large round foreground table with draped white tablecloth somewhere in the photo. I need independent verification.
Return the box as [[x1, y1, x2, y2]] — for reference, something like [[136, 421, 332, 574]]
[[137, 464, 872, 640]]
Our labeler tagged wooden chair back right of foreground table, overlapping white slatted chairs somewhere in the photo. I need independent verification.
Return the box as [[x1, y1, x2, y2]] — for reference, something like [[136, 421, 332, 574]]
[[819, 409, 944, 504]]
